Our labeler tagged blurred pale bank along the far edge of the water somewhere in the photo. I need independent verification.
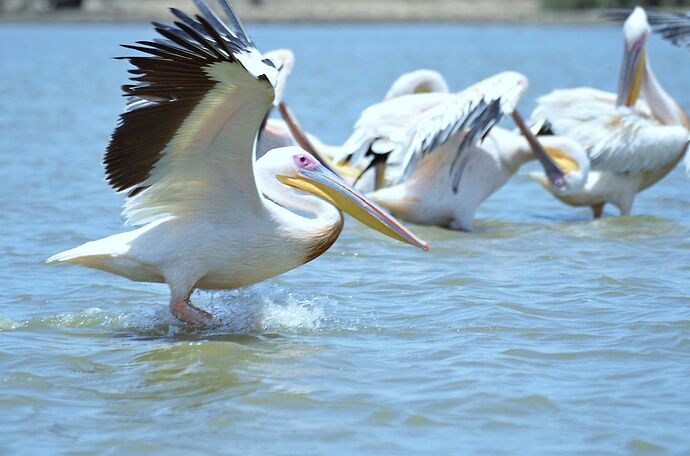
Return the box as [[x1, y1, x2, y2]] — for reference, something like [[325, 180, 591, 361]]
[[0, 0, 606, 25]]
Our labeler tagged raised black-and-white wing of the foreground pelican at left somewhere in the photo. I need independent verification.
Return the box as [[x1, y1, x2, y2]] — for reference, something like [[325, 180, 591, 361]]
[[104, 0, 276, 225]]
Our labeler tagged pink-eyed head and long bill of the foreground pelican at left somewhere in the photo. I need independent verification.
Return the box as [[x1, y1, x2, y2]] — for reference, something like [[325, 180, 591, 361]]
[[259, 146, 429, 251]]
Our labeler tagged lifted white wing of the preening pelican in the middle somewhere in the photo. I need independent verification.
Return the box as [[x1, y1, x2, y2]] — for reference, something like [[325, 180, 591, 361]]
[[338, 72, 527, 183]]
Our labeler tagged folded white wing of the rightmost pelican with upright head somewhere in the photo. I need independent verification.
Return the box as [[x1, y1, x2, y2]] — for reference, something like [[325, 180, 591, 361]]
[[533, 88, 688, 174]]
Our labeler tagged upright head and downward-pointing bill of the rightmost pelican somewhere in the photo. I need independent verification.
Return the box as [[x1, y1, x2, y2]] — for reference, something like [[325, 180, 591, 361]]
[[616, 6, 651, 106]]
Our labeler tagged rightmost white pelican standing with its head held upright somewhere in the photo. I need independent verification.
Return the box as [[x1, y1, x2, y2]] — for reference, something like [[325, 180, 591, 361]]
[[533, 7, 690, 218]]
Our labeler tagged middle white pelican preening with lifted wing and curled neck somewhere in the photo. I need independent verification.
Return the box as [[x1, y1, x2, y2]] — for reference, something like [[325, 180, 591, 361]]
[[338, 72, 588, 231]]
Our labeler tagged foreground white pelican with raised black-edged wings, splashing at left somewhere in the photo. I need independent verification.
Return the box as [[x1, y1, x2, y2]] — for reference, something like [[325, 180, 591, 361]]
[[48, 0, 428, 324]]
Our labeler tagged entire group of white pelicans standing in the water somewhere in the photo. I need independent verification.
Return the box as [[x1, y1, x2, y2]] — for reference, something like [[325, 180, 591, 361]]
[[48, 0, 690, 325]]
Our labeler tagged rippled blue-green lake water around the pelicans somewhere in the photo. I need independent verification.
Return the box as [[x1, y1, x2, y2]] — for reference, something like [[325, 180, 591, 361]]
[[0, 24, 690, 455]]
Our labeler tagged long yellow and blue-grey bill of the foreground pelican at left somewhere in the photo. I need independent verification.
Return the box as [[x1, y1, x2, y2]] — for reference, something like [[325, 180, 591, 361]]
[[276, 165, 429, 251]]
